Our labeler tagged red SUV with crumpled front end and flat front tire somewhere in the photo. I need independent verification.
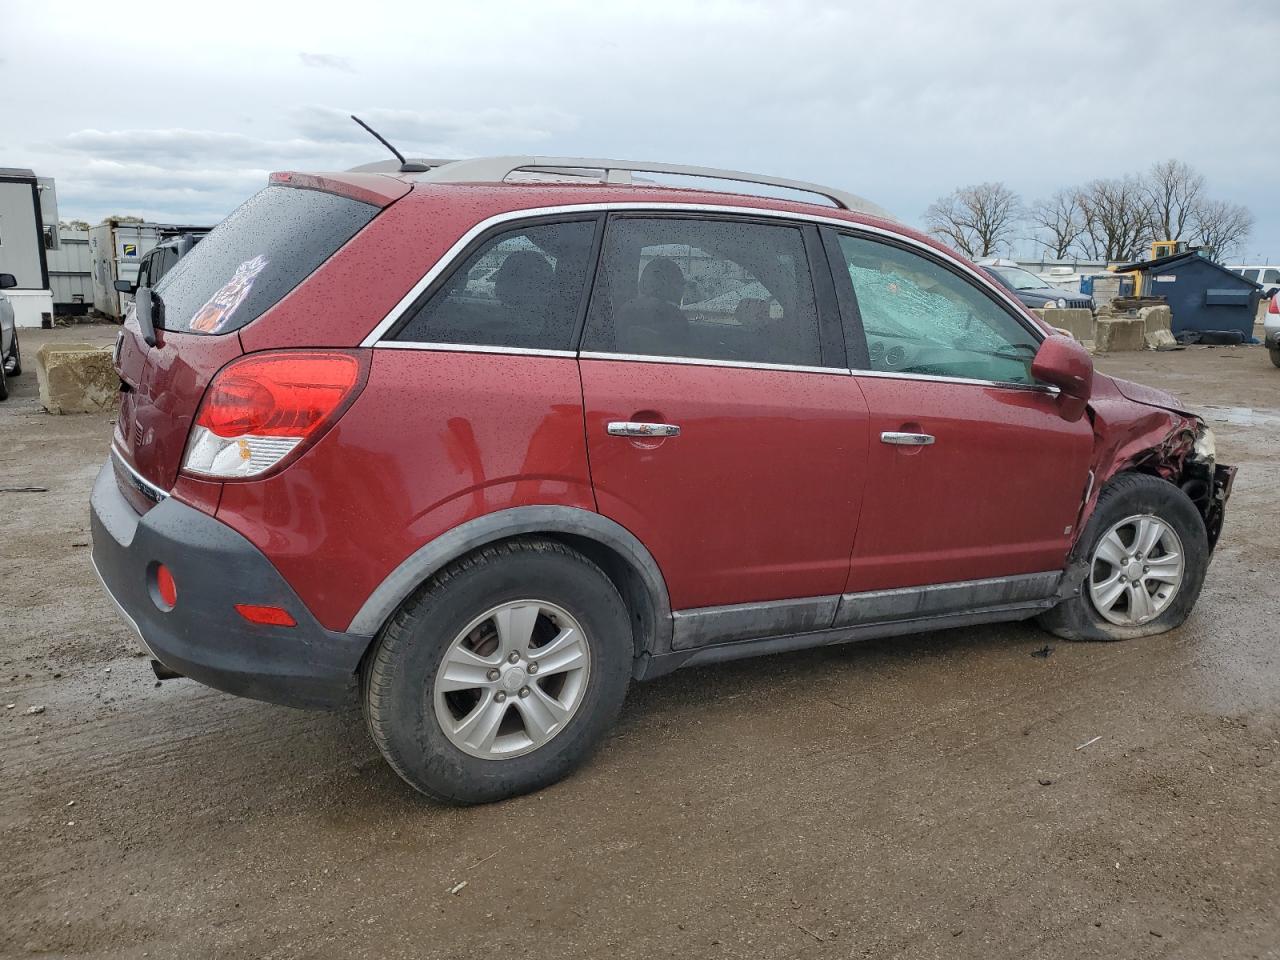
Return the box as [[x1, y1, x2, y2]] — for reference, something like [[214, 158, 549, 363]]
[[92, 157, 1235, 803]]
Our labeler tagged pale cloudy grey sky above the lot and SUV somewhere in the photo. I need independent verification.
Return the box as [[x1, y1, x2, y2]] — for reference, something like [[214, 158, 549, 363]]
[[0, 0, 1280, 262]]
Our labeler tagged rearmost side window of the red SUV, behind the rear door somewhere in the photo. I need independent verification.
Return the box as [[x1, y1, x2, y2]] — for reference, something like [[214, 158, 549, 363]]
[[394, 220, 595, 349]]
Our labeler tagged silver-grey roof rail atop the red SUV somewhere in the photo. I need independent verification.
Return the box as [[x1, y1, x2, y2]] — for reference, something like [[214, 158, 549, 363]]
[[415, 156, 895, 220]]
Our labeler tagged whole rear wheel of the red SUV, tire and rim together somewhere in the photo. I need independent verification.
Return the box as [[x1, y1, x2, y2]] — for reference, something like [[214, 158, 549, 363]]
[[365, 540, 632, 804]]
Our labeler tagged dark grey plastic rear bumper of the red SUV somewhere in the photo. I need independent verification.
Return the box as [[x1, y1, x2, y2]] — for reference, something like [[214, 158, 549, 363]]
[[90, 463, 371, 708]]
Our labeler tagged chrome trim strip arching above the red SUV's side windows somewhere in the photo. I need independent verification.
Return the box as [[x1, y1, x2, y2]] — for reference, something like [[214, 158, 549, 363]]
[[360, 200, 1048, 350]]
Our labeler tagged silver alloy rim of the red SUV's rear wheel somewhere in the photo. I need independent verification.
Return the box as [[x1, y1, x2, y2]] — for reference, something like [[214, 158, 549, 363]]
[[431, 600, 591, 760]]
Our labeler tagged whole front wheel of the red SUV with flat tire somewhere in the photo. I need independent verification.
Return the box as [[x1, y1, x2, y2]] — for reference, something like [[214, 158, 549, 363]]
[[1039, 474, 1210, 640]]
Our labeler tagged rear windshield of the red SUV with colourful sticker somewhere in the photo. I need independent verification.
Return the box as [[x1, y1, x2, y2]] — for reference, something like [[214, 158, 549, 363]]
[[156, 187, 379, 334]]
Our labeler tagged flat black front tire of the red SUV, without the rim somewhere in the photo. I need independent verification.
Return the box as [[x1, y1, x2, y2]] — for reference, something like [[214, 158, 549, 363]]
[[1037, 474, 1210, 640]]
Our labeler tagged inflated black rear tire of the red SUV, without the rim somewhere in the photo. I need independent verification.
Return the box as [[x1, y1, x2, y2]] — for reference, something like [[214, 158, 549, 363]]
[[364, 539, 634, 804]]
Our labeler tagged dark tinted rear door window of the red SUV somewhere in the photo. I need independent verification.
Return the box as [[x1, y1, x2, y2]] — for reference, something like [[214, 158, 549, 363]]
[[582, 216, 822, 366]]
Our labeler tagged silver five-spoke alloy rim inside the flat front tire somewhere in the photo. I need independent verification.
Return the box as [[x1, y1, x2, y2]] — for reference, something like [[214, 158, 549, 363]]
[[1089, 515, 1185, 627]]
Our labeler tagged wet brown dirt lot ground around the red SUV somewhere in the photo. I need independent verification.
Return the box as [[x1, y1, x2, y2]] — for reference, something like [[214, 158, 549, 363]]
[[0, 328, 1280, 960]]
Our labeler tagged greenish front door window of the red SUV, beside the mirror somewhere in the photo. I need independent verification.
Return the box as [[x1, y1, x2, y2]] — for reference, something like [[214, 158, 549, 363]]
[[840, 236, 1039, 384]]
